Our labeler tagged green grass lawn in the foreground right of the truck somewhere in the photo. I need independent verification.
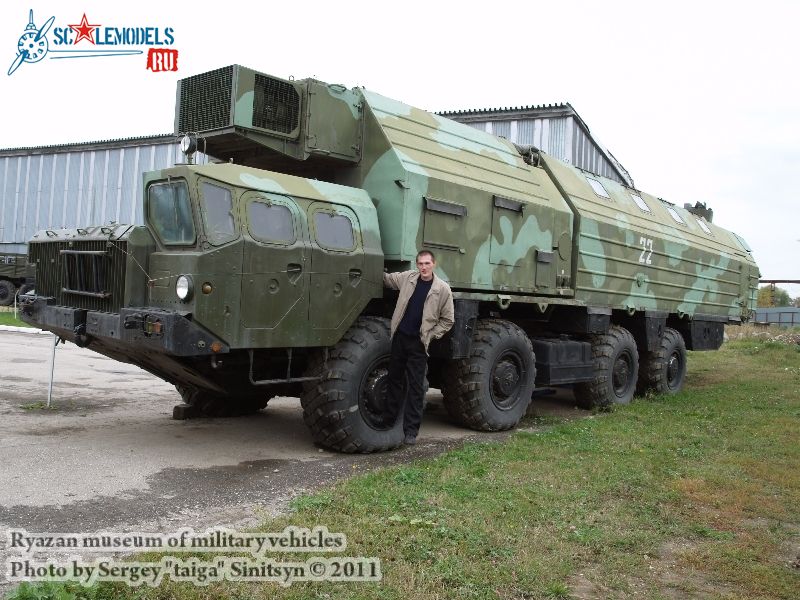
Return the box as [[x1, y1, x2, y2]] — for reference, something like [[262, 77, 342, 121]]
[[6, 339, 800, 600]]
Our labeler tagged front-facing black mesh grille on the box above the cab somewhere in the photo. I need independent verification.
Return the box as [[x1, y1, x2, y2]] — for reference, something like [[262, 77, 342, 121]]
[[178, 67, 233, 133]]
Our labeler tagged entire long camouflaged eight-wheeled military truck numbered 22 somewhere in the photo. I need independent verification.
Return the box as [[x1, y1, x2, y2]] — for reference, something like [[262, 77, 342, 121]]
[[17, 65, 759, 452]]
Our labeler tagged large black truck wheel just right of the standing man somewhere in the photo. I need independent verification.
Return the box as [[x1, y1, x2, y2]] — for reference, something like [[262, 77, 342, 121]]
[[442, 319, 536, 431]]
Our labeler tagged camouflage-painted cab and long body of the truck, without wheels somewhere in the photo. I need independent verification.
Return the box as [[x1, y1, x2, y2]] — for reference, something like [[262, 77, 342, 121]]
[[26, 66, 758, 368]]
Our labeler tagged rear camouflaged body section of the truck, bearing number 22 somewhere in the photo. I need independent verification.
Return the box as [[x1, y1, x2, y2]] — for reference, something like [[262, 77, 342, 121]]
[[544, 157, 755, 320]]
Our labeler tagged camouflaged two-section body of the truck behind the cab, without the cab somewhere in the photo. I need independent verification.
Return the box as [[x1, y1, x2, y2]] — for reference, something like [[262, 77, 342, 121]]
[[180, 67, 754, 319]]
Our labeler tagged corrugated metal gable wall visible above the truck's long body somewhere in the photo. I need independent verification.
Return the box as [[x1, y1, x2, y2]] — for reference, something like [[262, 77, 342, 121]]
[[448, 115, 626, 184]]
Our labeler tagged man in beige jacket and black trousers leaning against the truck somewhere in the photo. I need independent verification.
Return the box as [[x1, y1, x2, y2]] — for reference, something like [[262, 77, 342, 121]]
[[383, 250, 454, 444]]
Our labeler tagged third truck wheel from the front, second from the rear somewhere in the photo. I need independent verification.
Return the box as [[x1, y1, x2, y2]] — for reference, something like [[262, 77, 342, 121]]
[[574, 325, 639, 408]]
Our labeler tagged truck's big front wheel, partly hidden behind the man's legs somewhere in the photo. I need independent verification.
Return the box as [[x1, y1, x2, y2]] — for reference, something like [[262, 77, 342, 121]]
[[300, 317, 403, 453]]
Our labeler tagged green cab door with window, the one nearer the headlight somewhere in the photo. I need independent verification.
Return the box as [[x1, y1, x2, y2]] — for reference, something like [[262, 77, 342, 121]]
[[241, 192, 310, 347]]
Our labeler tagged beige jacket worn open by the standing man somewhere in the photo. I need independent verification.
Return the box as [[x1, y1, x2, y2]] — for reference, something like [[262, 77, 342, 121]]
[[383, 271, 455, 352]]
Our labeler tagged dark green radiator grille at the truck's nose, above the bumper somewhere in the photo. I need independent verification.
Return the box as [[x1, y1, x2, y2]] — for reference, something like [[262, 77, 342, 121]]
[[30, 240, 128, 313]]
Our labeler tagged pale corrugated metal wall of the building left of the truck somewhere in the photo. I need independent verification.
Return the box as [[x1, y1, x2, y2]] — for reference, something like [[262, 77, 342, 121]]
[[0, 140, 207, 253]]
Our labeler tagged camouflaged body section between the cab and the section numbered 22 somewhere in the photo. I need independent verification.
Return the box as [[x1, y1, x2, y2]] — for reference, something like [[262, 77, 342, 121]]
[[356, 91, 573, 295]]
